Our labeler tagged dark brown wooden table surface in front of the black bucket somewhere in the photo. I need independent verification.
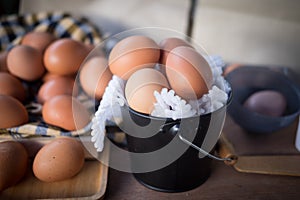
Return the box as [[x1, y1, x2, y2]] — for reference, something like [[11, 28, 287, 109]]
[[105, 118, 300, 200]]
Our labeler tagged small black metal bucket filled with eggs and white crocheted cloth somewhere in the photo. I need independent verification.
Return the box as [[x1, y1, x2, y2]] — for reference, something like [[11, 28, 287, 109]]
[[121, 95, 231, 192]]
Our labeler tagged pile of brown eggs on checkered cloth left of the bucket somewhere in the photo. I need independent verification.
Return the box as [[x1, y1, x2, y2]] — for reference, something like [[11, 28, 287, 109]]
[[0, 32, 93, 131]]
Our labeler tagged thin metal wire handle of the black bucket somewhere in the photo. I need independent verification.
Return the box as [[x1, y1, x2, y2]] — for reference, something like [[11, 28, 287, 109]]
[[171, 124, 233, 163]]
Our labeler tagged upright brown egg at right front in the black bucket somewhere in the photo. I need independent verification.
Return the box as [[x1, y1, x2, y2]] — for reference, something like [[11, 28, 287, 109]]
[[166, 46, 213, 100]]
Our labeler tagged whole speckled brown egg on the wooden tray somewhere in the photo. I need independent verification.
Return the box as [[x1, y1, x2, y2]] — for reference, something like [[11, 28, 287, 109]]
[[32, 137, 84, 182]]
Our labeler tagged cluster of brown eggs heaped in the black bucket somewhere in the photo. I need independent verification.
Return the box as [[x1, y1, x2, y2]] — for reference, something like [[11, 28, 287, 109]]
[[108, 35, 213, 114]]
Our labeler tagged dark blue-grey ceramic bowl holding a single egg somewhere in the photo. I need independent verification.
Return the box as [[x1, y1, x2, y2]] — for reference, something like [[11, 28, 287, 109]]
[[226, 66, 300, 133]]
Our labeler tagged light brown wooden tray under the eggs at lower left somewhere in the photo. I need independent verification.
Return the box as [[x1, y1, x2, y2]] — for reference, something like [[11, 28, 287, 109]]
[[0, 135, 108, 199]]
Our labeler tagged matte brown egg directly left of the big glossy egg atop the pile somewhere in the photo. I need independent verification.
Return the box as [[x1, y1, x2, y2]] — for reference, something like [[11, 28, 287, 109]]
[[7, 45, 45, 81]]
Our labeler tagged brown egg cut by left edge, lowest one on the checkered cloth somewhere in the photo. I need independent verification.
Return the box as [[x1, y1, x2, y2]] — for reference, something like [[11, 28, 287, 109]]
[[0, 95, 28, 128]]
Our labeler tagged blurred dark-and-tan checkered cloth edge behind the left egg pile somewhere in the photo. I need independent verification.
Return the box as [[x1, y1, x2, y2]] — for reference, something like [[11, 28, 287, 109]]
[[0, 12, 102, 51]]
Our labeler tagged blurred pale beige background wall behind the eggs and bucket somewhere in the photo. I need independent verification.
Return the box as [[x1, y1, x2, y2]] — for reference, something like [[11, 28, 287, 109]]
[[0, 0, 300, 73]]
